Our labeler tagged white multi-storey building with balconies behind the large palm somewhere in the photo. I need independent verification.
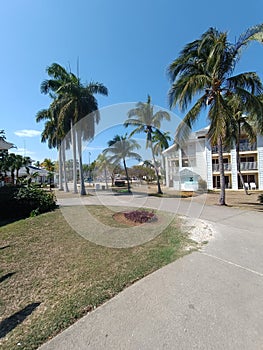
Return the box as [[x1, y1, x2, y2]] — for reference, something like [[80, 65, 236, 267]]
[[163, 127, 263, 191]]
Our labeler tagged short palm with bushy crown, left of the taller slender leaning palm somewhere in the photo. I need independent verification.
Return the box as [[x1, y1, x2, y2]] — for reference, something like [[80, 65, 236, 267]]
[[103, 134, 141, 192]]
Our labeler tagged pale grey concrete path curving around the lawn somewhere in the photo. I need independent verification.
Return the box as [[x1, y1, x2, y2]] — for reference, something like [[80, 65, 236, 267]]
[[41, 195, 263, 350]]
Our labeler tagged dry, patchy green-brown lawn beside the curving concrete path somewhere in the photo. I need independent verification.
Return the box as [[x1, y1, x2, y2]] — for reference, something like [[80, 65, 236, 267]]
[[0, 206, 195, 350]]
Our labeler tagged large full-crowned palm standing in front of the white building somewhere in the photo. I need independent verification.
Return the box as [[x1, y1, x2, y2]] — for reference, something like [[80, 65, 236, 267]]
[[168, 24, 263, 205]]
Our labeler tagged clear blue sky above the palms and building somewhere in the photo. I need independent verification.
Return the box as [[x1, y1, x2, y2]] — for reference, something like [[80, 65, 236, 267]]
[[0, 0, 263, 161]]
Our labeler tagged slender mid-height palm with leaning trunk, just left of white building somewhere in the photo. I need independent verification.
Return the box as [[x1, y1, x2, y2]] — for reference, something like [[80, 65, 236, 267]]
[[124, 95, 170, 194]]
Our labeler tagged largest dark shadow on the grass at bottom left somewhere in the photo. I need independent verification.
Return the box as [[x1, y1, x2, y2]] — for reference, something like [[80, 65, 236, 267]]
[[0, 303, 41, 338]]
